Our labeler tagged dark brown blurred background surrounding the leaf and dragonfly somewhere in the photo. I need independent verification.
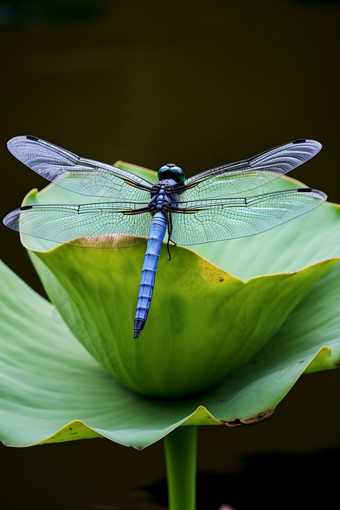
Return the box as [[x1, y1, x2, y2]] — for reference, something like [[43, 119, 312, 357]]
[[0, 0, 340, 510]]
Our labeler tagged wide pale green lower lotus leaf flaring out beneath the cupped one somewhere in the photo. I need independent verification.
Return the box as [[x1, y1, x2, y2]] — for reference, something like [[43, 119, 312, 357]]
[[0, 256, 340, 449]]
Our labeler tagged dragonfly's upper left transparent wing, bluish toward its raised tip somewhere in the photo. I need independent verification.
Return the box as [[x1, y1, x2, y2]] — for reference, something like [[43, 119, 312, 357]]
[[7, 136, 152, 201]]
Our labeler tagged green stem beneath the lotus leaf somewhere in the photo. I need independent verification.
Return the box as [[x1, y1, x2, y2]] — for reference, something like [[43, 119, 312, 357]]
[[164, 426, 197, 510]]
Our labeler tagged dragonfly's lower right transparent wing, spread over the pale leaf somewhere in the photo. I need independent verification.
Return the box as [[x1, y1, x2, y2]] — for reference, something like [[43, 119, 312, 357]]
[[171, 188, 327, 246]]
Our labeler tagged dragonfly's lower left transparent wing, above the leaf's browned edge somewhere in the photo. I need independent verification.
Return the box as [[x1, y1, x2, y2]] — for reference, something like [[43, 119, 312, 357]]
[[3, 203, 151, 248]]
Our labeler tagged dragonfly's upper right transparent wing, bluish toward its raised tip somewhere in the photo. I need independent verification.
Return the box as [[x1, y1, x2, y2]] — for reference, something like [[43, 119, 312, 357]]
[[179, 140, 322, 202]]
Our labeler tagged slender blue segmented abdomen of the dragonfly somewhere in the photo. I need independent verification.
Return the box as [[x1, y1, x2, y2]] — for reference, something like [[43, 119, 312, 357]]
[[134, 211, 167, 338]]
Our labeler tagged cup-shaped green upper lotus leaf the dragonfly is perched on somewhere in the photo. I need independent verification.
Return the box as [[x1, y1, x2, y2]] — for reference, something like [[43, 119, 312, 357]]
[[20, 163, 340, 398]]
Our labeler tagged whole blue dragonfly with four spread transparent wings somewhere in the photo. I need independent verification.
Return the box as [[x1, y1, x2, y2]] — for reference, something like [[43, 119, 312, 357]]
[[3, 136, 327, 338]]
